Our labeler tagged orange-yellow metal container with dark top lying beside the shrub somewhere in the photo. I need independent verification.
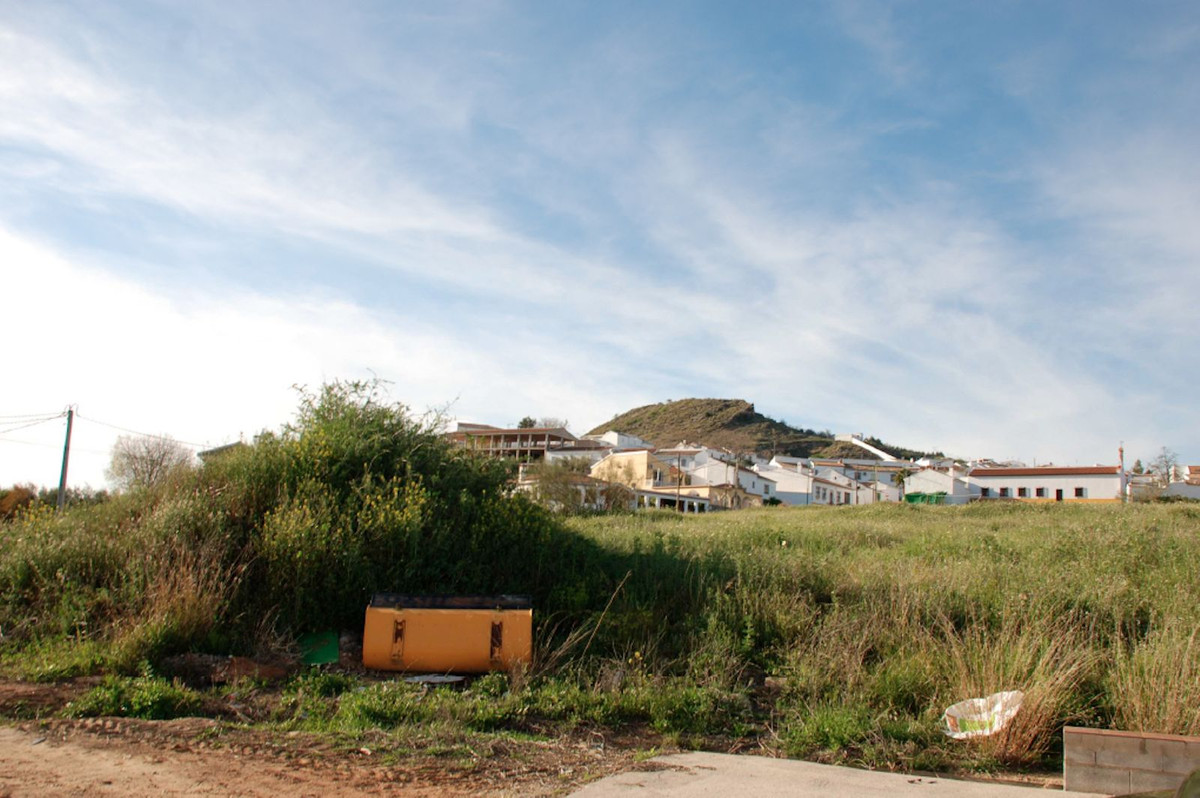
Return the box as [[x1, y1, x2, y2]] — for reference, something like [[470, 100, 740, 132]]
[[362, 593, 533, 673]]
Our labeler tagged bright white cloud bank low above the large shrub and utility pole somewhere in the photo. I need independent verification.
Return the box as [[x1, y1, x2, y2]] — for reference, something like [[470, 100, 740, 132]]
[[0, 222, 681, 485]]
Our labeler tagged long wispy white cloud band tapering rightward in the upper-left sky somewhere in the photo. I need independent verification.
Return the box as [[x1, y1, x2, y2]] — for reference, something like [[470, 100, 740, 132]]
[[0, 30, 497, 238]]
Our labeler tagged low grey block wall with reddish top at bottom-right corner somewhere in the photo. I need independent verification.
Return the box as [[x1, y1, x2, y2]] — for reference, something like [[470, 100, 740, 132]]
[[1062, 726, 1200, 796]]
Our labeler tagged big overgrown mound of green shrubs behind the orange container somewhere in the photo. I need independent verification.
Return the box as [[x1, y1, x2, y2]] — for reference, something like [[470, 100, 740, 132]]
[[0, 383, 609, 668]]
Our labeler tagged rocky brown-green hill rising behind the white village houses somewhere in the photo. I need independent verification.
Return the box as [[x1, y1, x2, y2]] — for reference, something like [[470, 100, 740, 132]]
[[587, 398, 935, 460]]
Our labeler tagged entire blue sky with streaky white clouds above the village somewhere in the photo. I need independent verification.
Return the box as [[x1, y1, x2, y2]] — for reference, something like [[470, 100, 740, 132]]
[[0, 0, 1200, 487]]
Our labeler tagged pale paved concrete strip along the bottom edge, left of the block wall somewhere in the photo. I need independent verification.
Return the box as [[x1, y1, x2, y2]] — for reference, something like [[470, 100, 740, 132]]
[[572, 754, 1100, 798]]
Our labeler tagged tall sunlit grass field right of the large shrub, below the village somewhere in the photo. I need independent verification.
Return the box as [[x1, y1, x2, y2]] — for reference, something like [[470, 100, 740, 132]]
[[556, 503, 1200, 767]]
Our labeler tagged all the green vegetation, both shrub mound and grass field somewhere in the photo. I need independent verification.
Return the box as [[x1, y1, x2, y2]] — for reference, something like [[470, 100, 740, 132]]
[[0, 385, 1200, 769]]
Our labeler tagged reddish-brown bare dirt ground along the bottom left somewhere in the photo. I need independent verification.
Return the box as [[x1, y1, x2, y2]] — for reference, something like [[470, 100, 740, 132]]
[[0, 680, 655, 798]]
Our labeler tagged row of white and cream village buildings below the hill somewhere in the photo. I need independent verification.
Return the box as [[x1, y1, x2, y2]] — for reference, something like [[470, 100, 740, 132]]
[[449, 406, 1200, 512]]
